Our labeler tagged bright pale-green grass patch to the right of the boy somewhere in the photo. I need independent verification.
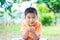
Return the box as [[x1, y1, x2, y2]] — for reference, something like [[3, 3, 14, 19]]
[[42, 26, 60, 37]]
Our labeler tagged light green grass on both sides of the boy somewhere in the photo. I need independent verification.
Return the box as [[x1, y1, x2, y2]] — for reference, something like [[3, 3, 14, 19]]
[[0, 23, 60, 37]]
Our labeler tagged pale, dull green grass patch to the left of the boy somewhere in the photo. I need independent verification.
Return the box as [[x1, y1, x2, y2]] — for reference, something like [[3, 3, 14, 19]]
[[0, 23, 21, 32]]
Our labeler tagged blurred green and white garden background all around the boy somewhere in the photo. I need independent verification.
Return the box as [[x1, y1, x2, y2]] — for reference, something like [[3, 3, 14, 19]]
[[0, 0, 60, 40]]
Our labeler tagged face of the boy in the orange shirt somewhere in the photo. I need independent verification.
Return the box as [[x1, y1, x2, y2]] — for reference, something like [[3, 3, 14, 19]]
[[25, 13, 37, 25]]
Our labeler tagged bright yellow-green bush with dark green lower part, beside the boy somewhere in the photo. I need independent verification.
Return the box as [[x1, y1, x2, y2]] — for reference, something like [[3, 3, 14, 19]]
[[37, 4, 57, 25]]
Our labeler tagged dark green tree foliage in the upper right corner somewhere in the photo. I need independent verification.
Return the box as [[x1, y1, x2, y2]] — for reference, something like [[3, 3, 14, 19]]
[[37, 0, 60, 12]]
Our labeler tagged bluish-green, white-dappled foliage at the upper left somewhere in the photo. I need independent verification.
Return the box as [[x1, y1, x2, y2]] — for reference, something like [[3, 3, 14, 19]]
[[0, 0, 21, 19]]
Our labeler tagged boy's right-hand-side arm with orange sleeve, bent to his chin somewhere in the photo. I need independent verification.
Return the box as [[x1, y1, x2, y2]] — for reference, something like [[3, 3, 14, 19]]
[[31, 23, 42, 40]]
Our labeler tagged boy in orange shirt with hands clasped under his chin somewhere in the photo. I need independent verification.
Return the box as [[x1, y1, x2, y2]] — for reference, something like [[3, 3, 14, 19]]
[[22, 7, 42, 40]]
